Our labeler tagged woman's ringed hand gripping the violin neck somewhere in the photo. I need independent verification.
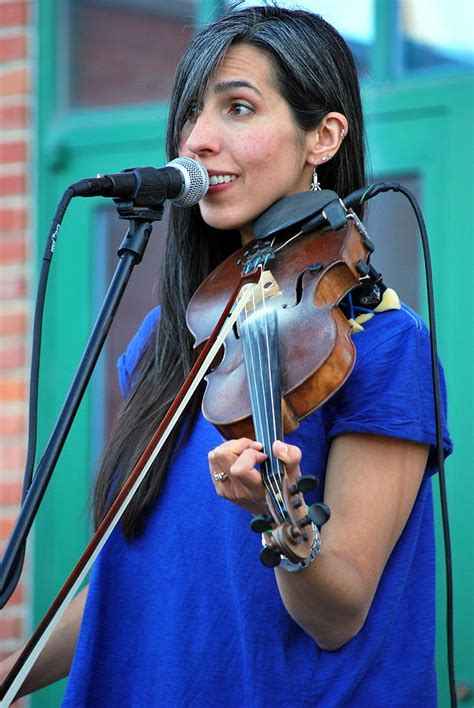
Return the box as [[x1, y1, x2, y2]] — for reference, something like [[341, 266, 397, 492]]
[[208, 438, 301, 514]]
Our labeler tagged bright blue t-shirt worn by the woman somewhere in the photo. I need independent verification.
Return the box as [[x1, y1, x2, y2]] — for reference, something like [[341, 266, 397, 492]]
[[63, 307, 451, 708]]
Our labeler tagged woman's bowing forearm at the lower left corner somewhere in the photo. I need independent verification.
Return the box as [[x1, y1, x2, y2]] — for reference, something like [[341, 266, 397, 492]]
[[0, 588, 87, 696]]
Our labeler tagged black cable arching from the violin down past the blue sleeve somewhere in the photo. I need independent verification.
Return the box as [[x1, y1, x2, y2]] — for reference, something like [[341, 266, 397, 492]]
[[343, 182, 457, 708]]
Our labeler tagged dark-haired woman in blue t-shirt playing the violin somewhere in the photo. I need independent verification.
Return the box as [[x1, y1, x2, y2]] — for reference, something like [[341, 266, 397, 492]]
[[0, 6, 450, 708]]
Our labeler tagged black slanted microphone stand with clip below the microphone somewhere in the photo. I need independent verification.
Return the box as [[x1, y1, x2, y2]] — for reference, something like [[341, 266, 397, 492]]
[[0, 199, 163, 607]]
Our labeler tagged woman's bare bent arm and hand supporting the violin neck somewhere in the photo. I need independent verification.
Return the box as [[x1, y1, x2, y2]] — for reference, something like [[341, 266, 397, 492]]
[[210, 434, 428, 651]]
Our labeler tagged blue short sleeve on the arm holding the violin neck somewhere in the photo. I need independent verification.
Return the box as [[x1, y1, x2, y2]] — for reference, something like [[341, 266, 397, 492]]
[[323, 306, 452, 466]]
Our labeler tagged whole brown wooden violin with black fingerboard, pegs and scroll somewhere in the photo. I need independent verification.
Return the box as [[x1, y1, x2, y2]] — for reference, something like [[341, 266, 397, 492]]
[[187, 200, 373, 567]]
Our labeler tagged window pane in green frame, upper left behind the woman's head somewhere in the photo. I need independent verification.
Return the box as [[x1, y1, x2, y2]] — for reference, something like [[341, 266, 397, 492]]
[[58, 0, 196, 109]]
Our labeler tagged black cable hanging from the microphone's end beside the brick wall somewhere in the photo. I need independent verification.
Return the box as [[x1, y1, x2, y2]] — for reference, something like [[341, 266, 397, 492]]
[[0, 188, 74, 607]]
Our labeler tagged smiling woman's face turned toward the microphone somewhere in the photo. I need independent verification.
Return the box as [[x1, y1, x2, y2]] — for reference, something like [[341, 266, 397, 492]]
[[180, 44, 313, 242]]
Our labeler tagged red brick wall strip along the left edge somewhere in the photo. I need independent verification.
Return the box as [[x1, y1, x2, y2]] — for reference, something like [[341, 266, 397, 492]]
[[0, 0, 33, 688]]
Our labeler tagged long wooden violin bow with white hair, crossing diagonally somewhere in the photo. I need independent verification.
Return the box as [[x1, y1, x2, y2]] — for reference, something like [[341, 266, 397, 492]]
[[0, 269, 260, 708]]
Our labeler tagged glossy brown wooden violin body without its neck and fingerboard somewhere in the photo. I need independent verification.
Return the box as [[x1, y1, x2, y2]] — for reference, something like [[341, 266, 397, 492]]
[[187, 220, 371, 438]]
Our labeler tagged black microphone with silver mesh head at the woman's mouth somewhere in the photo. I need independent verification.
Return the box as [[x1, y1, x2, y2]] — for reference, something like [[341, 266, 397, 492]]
[[69, 157, 209, 208]]
